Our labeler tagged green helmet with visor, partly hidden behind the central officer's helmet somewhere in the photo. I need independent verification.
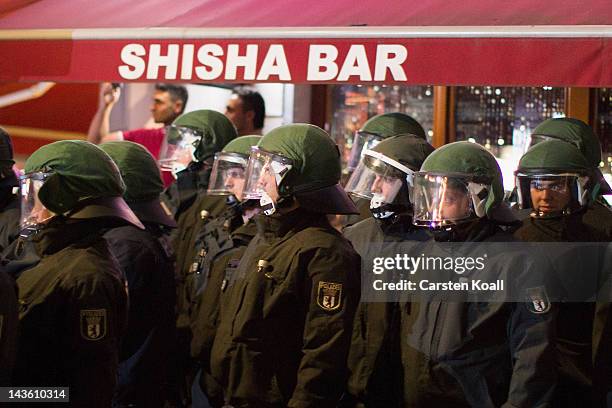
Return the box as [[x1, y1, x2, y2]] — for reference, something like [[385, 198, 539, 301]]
[[207, 135, 261, 201]]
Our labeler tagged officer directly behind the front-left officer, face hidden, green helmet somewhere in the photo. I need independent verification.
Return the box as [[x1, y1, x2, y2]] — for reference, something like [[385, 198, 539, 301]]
[[100, 141, 176, 407]]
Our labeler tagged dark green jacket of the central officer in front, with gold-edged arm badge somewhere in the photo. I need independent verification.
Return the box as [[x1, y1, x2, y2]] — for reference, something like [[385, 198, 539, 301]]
[[211, 209, 360, 407]]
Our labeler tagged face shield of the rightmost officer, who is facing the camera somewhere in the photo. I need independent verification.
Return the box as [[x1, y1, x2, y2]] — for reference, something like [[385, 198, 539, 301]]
[[516, 172, 589, 218]]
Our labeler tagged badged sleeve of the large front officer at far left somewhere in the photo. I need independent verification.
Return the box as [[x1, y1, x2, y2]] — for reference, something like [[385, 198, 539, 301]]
[[64, 270, 127, 407]]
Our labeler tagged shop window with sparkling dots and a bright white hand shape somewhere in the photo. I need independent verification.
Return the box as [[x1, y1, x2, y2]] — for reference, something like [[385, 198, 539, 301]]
[[455, 86, 565, 191]]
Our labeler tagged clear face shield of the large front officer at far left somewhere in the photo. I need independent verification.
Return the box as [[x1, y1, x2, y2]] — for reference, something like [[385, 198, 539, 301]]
[[19, 172, 55, 231]]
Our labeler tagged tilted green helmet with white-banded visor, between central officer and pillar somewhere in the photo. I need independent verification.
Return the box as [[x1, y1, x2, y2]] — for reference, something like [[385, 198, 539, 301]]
[[345, 134, 434, 218]]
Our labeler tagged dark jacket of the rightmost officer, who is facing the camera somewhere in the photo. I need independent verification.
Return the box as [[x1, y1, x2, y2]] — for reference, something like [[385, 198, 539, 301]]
[[515, 213, 612, 407]]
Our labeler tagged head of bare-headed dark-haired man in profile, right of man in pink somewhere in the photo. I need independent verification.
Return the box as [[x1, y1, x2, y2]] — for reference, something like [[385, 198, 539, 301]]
[[225, 88, 266, 136]]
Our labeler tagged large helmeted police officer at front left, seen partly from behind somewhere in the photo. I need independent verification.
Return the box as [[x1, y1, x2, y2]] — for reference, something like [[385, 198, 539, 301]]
[[14, 141, 143, 407]]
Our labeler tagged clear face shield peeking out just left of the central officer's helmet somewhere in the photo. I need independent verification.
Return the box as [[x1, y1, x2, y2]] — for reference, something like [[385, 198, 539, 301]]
[[207, 152, 248, 201]]
